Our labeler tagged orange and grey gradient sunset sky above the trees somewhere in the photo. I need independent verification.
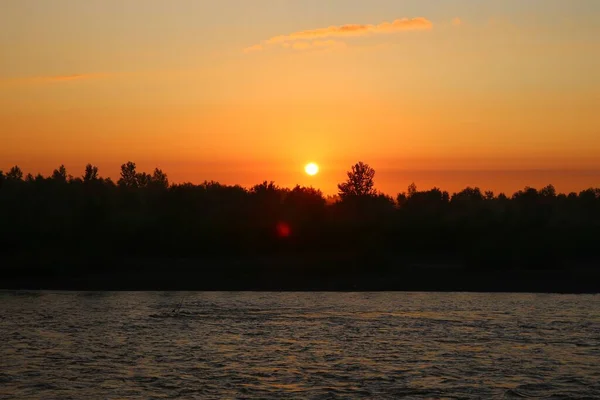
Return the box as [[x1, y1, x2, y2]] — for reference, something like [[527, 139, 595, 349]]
[[0, 0, 600, 194]]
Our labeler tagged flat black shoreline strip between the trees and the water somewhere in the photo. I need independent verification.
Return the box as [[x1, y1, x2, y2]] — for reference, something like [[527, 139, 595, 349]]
[[0, 257, 600, 293]]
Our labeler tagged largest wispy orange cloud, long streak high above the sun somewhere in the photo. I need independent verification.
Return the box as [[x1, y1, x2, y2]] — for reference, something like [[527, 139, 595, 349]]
[[244, 17, 433, 53]]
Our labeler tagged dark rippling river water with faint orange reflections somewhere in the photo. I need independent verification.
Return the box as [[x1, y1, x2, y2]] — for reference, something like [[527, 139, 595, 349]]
[[0, 292, 600, 399]]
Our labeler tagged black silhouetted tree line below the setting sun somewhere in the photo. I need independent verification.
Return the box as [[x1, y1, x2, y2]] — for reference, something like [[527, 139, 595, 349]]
[[0, 162, 600, 269]]
